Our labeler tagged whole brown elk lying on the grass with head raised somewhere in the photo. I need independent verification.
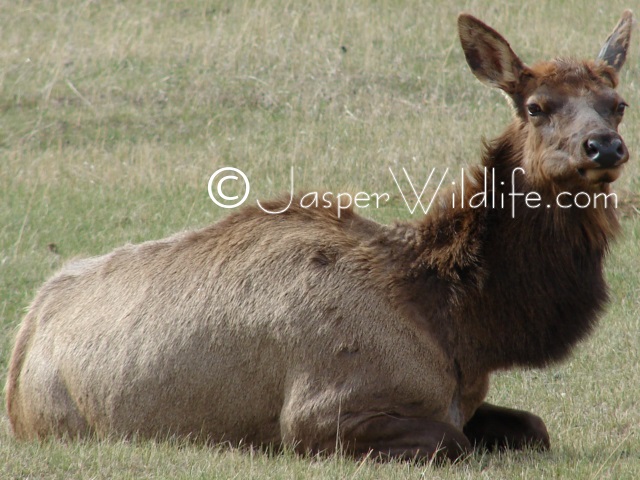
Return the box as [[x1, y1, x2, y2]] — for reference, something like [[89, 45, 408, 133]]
[[6, 11, 633, 460]]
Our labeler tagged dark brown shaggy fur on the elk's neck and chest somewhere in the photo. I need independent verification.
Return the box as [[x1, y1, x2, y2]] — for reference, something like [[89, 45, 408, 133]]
[[410, 119, 618, 373]]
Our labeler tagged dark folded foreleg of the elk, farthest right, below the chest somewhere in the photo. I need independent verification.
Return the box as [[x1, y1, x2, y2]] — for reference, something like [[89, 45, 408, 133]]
[[463, 403, 550, 450]]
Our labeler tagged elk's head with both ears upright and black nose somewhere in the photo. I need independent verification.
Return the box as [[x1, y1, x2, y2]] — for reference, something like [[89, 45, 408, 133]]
[[458, 10, 633, 191]]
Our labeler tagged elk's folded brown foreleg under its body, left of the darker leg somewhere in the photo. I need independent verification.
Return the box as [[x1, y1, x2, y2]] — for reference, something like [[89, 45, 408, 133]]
[[340, 413, 471, 461]]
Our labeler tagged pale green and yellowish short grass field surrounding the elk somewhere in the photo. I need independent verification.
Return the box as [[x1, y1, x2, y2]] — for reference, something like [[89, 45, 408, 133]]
[[0, 0, 640, 479]]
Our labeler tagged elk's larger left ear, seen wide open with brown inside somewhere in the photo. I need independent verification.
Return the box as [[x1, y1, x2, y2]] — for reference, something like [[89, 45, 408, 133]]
[[458, 13, 526, 95]]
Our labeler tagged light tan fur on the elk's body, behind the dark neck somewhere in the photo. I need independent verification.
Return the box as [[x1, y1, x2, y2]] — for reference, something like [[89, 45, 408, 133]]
[[7, 204, 462, 445]]
